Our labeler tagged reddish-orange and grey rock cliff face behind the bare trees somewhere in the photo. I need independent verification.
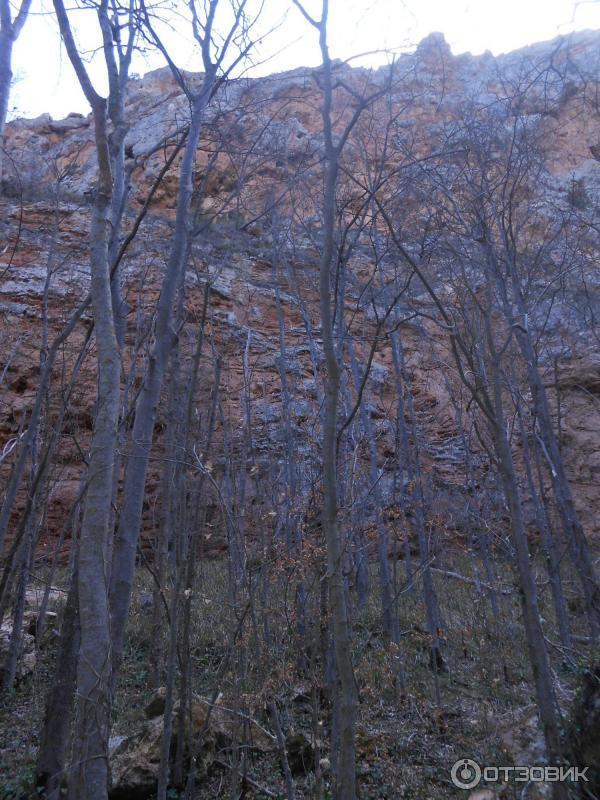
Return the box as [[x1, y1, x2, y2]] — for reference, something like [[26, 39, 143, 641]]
[[0, 26, 600, 546]]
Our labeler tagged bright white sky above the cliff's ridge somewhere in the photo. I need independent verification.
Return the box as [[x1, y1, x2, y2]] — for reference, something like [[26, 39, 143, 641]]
[[11, 0, 600, 118]]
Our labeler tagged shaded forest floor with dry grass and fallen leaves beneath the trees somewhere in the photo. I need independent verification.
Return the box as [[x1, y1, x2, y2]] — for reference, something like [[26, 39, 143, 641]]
[[0, 553, 593, 800]]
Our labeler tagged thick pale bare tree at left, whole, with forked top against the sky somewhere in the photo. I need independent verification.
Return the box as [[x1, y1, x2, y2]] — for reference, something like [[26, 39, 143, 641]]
[[54, 0, 134, 800]]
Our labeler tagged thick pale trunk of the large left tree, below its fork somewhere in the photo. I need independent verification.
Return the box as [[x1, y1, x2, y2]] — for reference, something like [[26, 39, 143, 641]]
[[72, 161, 120, 800]]
